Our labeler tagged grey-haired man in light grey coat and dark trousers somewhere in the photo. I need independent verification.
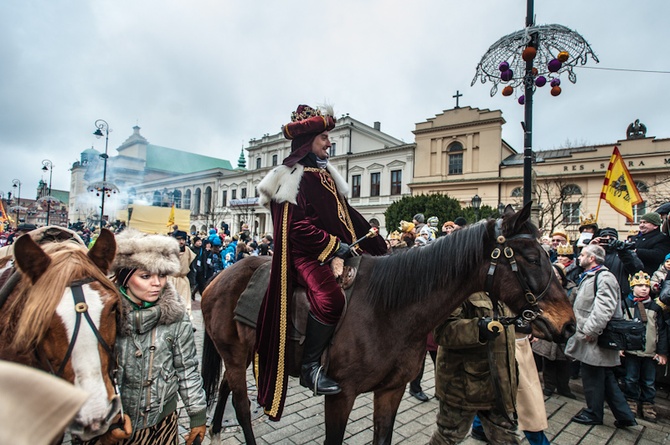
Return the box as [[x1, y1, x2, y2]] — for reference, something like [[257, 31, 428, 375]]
[[565, 244, 637, 428]]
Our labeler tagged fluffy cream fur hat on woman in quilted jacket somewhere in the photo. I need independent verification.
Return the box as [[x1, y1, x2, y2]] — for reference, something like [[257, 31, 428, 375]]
[[112, 229, 181, 275]]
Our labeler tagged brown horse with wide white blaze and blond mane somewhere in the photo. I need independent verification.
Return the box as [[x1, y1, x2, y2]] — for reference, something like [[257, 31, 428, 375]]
[[0, 229, 121, 440]]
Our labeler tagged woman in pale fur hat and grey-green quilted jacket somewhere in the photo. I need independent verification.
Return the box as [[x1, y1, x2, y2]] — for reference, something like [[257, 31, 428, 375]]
[[86, 229, 207, 445]]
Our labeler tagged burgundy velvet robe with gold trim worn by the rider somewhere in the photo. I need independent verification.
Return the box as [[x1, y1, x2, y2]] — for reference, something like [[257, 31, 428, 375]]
[[254, 167, 386, 420]]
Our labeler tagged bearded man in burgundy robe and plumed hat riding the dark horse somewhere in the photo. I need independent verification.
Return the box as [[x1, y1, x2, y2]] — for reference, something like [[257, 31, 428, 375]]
[[255, 105, 386, 420]]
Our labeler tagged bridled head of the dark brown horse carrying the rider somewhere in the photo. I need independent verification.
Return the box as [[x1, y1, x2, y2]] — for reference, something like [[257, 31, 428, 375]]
[[486, 204, 575, 342]]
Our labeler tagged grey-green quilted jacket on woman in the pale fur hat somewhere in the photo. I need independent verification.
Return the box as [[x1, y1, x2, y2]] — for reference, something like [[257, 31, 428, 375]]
[[116, 283, 207, 431]]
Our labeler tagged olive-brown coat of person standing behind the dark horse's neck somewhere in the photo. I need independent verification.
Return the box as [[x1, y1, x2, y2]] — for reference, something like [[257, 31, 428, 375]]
[[433, 292, 518, 412]]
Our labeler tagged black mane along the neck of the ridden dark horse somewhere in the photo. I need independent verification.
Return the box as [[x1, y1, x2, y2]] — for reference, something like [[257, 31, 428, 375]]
[[366, 220, 493, 309]]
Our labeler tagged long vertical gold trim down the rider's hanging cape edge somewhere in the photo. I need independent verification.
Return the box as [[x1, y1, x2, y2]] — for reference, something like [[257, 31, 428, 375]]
[[266, 202, 289, 417]]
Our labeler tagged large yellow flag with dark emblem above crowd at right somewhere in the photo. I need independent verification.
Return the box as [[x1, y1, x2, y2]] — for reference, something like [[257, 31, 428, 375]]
[[600, 147, 643, 222]]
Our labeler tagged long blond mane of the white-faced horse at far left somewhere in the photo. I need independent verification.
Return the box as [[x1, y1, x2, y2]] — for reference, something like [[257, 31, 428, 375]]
[[7, 239, 116, 351]]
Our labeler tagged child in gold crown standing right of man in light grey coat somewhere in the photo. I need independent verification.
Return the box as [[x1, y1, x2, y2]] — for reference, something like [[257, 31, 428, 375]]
[[623, 271, 668, 422]]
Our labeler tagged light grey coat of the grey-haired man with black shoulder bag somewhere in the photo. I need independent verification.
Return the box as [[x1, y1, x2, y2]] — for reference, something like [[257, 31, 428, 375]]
[[565, 266, 622, 367]]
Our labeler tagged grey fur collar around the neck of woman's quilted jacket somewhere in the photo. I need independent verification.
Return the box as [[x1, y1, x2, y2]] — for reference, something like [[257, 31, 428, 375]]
[[118, 283, 186, 336]]
